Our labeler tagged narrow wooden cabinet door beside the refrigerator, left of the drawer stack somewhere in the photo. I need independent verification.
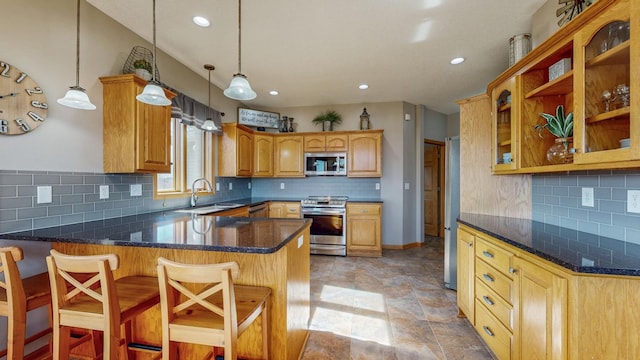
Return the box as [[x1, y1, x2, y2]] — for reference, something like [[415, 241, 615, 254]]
[[456, 228, 475, 325]]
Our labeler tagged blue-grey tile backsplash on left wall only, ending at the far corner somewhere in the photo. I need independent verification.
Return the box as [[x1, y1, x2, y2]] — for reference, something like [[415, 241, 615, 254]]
[[0, 170, 251, 233]]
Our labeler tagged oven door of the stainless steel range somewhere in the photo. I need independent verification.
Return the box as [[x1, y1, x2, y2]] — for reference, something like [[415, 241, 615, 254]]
[[302, 208, 347, 245]]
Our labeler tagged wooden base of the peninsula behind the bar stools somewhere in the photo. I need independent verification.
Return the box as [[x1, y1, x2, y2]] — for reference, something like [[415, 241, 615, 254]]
[[53, 226, 310, 360]]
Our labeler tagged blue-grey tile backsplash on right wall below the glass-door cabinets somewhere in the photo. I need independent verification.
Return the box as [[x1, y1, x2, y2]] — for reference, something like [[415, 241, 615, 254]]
[[532, 170, 640, 244]]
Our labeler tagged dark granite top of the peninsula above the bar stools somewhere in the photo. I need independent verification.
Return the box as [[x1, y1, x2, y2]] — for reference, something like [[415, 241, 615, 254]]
[[0, 210, 311, 254]]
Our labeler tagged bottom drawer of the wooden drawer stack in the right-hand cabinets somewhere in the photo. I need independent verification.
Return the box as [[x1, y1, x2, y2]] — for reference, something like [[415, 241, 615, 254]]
[[476, 299, 513, 360]]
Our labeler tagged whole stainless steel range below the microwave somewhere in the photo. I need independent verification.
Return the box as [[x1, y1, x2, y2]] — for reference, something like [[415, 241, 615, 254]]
[[301, 196, 349, 256]]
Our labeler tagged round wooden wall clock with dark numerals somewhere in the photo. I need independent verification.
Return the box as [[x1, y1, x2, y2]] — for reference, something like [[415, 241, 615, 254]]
[[0, 61, 49, 135]]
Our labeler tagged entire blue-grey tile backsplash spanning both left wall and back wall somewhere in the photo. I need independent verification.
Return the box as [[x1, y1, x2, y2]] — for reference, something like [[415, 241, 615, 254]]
[[0, 170, 380, 233]]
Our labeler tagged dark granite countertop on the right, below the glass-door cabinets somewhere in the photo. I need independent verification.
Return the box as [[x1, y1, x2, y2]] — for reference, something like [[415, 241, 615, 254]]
[[458, 213, 640, 276]]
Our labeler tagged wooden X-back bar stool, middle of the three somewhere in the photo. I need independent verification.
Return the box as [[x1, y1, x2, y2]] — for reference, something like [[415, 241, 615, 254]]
[[47, 250, 160, 360]]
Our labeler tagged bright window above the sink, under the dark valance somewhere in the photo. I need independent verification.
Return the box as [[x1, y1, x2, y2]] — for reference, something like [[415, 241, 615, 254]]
[[154, 118, 214, 198]]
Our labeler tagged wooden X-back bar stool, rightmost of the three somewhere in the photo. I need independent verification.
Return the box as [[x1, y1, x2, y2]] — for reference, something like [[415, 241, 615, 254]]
[[158, 258, 271, 360]]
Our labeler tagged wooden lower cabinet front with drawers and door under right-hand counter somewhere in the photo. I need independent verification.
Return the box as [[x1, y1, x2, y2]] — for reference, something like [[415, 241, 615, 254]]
[[458, 225, 572, 360]]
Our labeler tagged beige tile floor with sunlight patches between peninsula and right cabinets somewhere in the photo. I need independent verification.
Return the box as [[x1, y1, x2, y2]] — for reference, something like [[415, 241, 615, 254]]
[[302, 238, 493, 360]]
